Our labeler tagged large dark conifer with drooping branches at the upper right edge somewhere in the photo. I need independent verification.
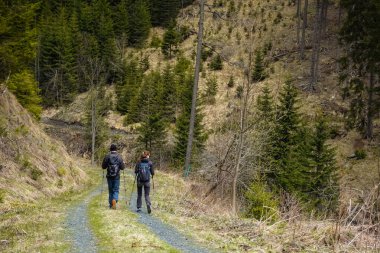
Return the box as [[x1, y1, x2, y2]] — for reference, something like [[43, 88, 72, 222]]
[[340, 0, 380, 139]]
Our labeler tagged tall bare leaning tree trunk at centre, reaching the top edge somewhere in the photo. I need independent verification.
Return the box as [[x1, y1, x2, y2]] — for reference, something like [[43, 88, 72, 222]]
[[185, 0, 204, 177]]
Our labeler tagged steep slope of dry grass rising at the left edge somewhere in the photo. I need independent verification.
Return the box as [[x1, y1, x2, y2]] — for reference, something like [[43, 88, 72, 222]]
[[0, 86, 88, 211]]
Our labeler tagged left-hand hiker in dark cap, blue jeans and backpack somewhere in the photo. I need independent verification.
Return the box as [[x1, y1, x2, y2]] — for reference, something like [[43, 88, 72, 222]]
[[102, 144, 125, 209]]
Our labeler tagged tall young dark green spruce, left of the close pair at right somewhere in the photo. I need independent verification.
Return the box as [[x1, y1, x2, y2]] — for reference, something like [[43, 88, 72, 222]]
[[267, 80, 310, 197]]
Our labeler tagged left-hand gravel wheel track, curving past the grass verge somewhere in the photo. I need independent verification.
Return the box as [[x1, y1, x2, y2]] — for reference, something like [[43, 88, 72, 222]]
[[66, 189, 100, 253]]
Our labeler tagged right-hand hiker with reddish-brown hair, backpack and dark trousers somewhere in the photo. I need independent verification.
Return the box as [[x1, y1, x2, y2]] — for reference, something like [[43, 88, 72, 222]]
[[135, 151, 154, 213]]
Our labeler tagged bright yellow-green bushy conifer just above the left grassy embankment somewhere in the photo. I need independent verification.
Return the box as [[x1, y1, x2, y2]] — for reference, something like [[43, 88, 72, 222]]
[[7, 70, 42, 119]]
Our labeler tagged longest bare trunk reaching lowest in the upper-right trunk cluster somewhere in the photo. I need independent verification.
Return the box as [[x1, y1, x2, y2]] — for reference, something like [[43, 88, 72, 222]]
[[309, 0, 321, 91]]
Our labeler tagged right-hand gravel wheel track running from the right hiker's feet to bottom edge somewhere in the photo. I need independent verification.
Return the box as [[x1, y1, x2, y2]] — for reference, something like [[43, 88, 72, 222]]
[[130, 192, 210, 253]]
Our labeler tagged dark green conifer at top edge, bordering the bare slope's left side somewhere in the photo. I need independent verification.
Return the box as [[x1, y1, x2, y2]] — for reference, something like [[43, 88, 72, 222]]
[[128, 0, 151, 47]]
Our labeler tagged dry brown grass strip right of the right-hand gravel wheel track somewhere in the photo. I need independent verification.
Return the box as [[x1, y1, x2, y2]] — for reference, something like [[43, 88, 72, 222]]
[[152, 172, 380, 252]]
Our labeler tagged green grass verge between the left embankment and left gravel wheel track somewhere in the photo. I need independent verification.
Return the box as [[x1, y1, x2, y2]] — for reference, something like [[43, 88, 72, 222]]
[[0, 167, 98, 253]]
